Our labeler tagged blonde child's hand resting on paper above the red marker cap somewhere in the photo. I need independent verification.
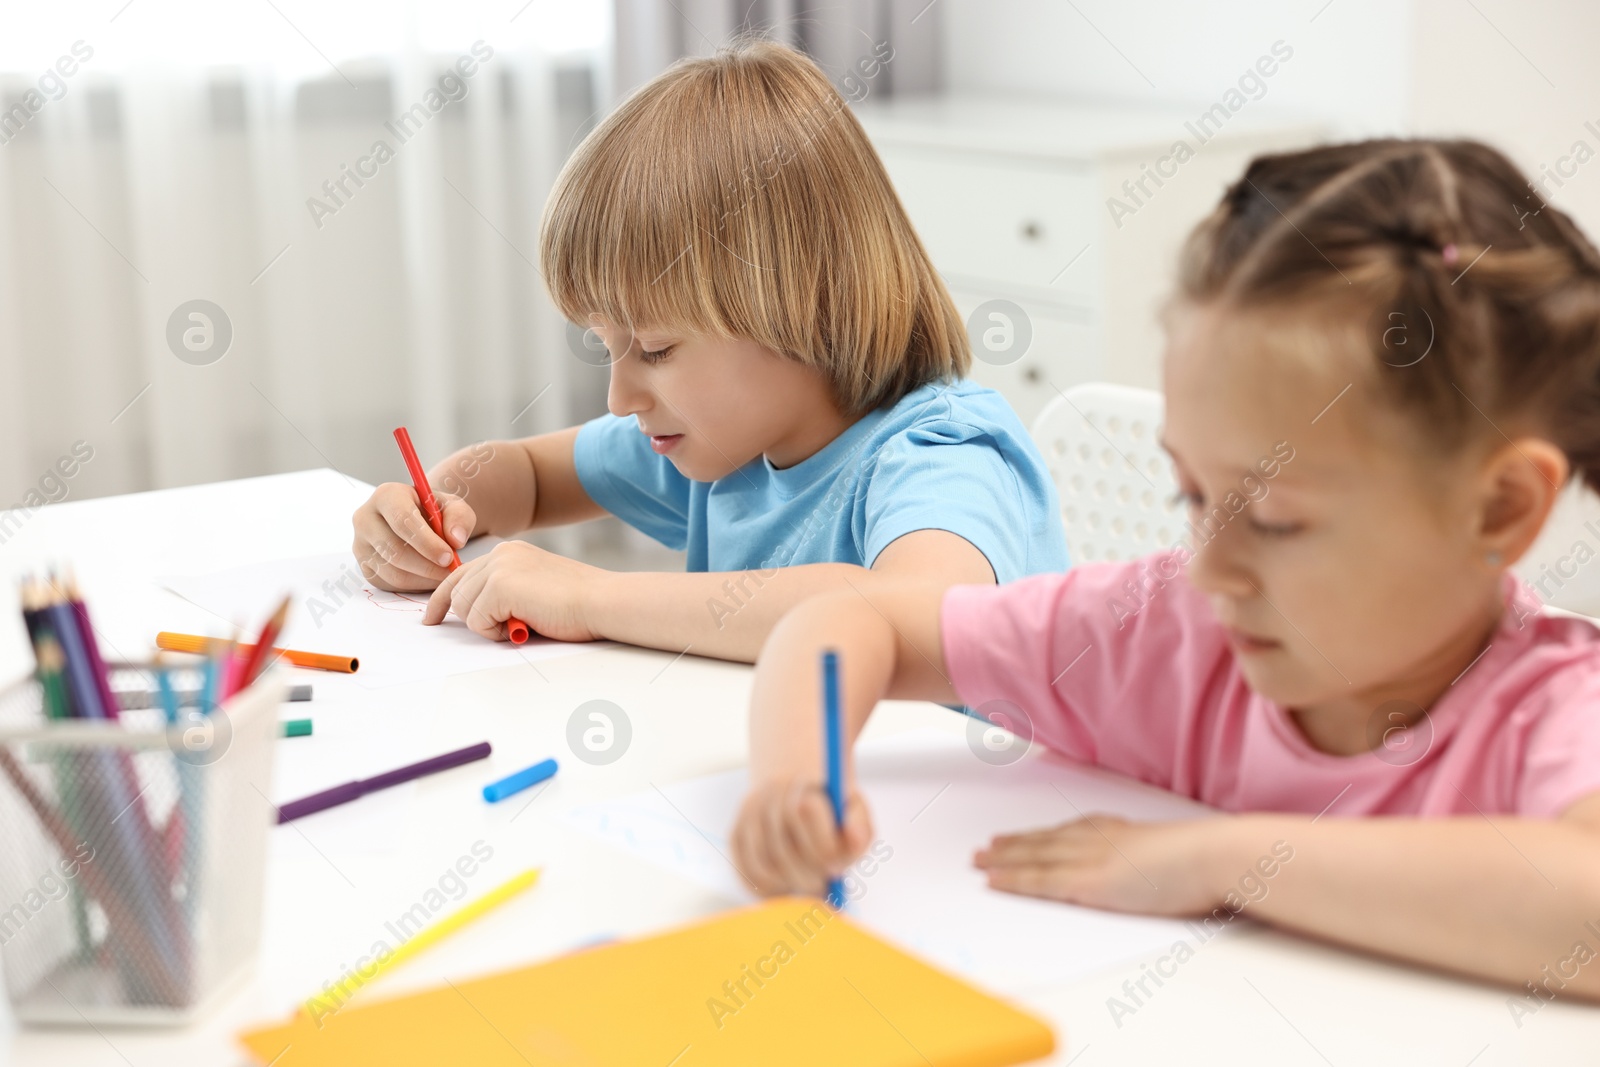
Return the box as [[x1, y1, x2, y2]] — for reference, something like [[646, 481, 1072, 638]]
[[422, 541, 608, 641]]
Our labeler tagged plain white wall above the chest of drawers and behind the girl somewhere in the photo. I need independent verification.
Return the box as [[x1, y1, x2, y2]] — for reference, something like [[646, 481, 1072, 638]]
[[942, 0, 1600, 614]]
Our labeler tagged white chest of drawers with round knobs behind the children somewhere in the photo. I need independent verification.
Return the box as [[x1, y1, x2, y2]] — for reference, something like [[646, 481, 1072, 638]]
[[856, 96, 1320, 424]]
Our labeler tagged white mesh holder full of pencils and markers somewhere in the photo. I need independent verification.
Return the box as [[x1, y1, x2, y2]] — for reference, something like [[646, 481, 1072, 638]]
[[0, 669, 283, 1025]]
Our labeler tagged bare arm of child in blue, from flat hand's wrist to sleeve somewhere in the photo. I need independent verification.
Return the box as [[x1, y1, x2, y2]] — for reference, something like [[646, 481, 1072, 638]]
[[584, 530, 994, 662]]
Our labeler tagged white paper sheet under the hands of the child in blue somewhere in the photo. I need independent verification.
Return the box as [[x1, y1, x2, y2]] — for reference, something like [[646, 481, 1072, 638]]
[[160, 556, 595, 689]]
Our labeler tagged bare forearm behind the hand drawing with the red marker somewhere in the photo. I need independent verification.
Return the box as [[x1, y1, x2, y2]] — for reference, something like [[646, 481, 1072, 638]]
[[427, 426, 605, 537]]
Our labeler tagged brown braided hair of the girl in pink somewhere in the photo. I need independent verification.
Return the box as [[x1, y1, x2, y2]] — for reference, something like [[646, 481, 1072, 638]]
[[1178, 139, 1600, 491]]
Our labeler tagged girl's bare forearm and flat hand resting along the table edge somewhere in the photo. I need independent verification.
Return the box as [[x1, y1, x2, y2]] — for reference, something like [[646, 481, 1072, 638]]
[[976, 795, 1600, 1000]]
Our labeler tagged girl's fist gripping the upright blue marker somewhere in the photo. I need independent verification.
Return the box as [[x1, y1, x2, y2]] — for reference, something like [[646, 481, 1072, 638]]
[[731, 777, 872, 896]]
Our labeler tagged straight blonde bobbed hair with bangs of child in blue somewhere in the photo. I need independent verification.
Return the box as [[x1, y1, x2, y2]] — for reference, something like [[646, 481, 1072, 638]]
[[539, 42, 971, 411]]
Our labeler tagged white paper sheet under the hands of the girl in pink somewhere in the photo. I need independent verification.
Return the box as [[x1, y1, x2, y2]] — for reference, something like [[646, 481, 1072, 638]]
[[565, 731, 1213, 993]]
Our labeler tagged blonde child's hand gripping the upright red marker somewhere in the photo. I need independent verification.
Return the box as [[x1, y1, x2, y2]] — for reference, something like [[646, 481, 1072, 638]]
[[350, 482, 478, 592]]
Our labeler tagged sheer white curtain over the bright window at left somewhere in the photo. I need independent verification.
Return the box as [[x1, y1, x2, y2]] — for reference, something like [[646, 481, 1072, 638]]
[[0, 0, 610, 509]]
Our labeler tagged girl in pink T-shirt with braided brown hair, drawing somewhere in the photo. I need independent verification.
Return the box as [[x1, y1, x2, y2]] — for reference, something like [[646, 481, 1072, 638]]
[[734, 141, 1600, 1003]]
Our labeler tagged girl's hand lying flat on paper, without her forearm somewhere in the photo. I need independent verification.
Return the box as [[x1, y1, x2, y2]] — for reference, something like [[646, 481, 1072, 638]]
[[973, 814, 1228, 915]]
